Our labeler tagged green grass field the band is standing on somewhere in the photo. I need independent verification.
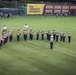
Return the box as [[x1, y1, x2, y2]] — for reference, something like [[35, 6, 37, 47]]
[[0, 16, 76, 75]]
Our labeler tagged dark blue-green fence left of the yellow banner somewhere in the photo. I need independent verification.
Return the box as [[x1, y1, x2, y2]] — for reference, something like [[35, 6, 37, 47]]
[[0, 6, 27, 16]]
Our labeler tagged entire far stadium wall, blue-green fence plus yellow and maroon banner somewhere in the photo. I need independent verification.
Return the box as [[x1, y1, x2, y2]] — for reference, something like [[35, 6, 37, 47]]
[[0, 4, 76, 16]]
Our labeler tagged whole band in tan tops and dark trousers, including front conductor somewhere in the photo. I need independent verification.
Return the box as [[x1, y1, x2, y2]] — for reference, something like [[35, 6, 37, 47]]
[[0, 28, 71, 49]]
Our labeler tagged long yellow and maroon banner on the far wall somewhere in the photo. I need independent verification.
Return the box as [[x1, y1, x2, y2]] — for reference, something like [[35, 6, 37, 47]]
[[27, 4, 76, 15]]
